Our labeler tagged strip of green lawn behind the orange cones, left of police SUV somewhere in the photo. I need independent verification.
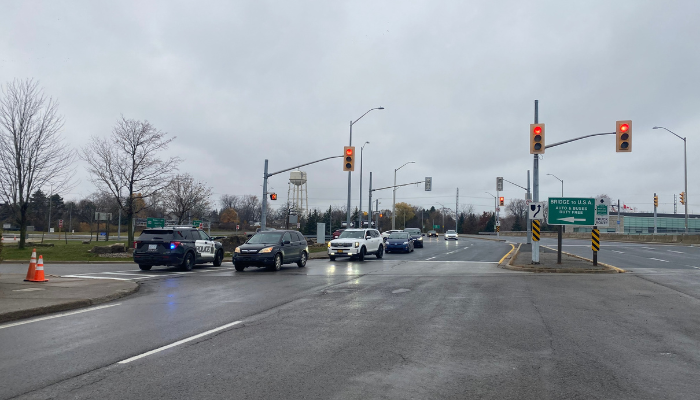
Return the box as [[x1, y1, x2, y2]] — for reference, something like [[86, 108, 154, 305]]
[[2, 240, 132, 264]]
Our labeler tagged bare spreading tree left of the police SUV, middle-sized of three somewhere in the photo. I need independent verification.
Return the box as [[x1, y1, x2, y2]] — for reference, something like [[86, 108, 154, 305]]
[[80, 116, 180, 243]]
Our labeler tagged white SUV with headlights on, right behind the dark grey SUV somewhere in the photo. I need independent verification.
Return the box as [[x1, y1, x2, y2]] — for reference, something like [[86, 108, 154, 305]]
[[328, 229, 384, 261]]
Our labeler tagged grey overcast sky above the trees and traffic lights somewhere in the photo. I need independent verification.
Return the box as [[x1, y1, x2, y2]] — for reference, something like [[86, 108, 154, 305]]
[[0, 0, 700, 213]]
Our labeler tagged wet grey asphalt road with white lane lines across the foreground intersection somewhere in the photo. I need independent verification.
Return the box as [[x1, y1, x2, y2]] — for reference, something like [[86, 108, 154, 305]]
[[0, 239, 700, 399]]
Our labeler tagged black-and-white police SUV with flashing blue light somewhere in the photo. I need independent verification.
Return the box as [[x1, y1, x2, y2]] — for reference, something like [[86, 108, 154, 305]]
[[134, 226, 224, 271]]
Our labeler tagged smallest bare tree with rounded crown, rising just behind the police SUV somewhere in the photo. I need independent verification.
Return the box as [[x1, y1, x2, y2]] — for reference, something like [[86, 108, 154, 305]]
[[163, 174, 211, 224]]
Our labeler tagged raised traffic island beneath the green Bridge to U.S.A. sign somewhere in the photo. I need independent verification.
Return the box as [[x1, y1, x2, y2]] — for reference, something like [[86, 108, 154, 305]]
[[501, 244, 625, 274]]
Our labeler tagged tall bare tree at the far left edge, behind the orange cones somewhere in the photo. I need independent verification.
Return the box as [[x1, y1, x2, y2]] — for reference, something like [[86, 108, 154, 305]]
[[0, 79, 76, 249]]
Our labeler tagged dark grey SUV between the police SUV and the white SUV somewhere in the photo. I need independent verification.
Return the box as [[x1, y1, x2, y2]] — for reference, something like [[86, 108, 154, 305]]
[[233, 230, 309, 272]]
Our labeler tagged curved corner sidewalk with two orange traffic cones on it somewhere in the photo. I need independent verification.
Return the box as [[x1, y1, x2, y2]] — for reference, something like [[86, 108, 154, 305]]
[[0, 274, 139, 323]]
